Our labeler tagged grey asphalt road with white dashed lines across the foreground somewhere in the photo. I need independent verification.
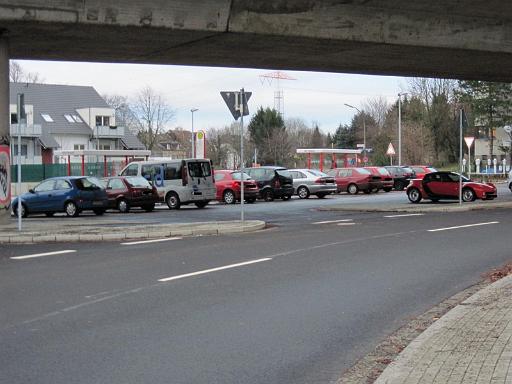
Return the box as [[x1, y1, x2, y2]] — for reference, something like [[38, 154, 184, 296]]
[[0, 190, 512, 384]]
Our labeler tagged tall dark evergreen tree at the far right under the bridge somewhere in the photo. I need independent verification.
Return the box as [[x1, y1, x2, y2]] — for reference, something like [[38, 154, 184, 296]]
[[456, 80, 512, 158]]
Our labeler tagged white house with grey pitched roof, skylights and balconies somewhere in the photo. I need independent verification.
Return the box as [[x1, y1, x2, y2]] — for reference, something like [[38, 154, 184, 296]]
[[10, 83, 144, 164]]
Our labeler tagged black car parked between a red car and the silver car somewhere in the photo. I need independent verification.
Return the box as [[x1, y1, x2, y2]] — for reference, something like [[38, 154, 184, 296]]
[[244, 166, 293, 201]]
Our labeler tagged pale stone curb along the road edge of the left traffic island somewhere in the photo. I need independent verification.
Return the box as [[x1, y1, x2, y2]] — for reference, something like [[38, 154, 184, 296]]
[[0, 220, 266, 244]]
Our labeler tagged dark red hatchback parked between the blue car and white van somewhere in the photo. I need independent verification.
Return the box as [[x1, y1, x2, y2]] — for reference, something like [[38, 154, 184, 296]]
[[103, 176, 160, 213]]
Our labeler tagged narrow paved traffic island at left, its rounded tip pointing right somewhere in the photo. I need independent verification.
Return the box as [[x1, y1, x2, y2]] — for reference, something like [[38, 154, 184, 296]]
[[0, 218, 266, 244]]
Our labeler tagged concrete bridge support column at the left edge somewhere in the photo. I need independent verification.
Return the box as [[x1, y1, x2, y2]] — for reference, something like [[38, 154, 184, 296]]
[[0, 33, 11, 224]]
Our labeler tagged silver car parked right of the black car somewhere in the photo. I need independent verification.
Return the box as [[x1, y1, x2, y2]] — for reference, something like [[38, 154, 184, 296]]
[[288, 169, 337, 199]]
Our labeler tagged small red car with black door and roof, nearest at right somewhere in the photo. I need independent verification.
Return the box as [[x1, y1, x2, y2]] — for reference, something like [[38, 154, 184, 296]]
[[407, 172, 498, 203]]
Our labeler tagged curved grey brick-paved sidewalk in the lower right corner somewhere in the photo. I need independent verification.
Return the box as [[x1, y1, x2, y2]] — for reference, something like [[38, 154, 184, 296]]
[[375, 276, 512, 384]]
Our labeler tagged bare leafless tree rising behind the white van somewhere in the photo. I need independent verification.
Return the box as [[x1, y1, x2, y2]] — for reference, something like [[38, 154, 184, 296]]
[[131, 87, 175, 150]]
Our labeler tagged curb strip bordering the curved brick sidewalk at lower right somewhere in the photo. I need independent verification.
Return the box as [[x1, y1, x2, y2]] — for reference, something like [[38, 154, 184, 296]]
[[374, 275, 512, 384]]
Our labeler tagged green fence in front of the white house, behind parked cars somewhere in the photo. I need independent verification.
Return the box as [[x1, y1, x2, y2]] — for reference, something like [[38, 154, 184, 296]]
[[11, 162, 124, 183]]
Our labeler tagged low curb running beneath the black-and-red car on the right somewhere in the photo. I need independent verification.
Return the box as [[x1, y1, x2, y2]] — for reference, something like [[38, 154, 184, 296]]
[[318, 202, 512, 213]]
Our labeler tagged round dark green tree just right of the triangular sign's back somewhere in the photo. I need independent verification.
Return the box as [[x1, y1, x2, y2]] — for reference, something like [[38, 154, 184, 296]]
[[248, 107, 290, 164]]
